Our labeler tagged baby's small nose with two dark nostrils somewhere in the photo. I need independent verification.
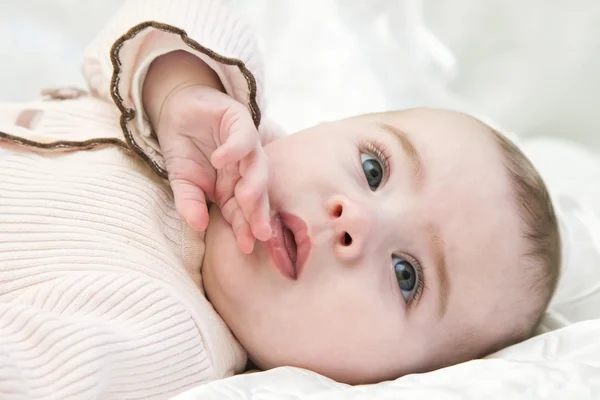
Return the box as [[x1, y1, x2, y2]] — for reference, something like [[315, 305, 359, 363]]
[[325, 195, 373, 263]]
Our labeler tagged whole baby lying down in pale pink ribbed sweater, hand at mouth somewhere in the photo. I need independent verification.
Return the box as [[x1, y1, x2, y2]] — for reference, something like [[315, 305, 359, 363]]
[[0, 0, 560, 399]]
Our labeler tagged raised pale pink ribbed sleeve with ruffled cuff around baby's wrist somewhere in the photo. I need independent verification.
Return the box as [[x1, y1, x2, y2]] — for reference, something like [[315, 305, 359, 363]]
[[83, 0, 278, 178]]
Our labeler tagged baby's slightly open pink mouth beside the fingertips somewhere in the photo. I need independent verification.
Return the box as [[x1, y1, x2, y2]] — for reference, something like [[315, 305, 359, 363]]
[[267, 213, 311, 280]]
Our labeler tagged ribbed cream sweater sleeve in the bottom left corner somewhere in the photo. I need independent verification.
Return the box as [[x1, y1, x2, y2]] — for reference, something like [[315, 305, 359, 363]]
[[0, 271, 221, 399]]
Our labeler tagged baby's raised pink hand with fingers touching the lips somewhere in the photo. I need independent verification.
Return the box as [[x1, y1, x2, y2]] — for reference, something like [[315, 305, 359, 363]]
[[155, 85, 271, 253]]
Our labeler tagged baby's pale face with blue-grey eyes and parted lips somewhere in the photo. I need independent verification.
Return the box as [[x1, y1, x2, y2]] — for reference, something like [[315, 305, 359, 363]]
[[203, 110, 523, 383]]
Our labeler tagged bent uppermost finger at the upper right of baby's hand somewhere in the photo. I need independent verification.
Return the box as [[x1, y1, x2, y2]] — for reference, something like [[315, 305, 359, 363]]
[[211, 107, 260, 168]]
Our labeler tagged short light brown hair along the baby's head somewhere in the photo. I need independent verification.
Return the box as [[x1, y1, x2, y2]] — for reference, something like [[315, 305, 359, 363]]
[[490, 128, 561, 347]]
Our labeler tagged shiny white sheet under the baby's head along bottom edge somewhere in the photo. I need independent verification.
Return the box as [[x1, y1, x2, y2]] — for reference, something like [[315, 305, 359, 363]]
[[175, 320, 600, 400]]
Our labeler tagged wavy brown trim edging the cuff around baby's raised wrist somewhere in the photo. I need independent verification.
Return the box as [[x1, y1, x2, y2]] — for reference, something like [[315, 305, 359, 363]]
[[110, 21, 261, 179]]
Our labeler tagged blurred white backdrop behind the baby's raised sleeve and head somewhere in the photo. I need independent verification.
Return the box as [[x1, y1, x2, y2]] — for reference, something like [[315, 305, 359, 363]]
[[0, 0, 600, 148]]
